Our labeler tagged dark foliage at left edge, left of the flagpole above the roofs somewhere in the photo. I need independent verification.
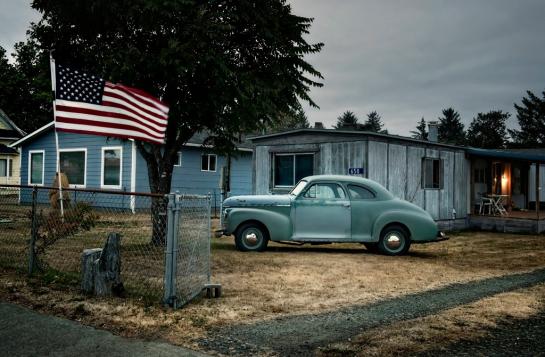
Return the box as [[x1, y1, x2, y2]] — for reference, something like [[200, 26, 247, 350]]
[[0, 40, 53, 133]]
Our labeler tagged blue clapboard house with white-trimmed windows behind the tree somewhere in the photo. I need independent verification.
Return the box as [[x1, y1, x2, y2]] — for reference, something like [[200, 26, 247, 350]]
[[11, 122, 252, 209]]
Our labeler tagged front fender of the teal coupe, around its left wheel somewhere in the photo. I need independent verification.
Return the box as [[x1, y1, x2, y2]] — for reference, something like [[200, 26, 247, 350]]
[[226, 208, 292, 241]]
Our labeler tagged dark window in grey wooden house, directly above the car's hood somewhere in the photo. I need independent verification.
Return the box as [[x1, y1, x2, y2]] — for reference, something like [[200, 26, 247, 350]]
[[273, 154, 314, 186]]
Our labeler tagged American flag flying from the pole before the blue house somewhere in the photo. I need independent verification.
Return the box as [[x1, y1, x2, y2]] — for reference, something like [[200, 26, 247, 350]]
[[54, 64, 168, 144]]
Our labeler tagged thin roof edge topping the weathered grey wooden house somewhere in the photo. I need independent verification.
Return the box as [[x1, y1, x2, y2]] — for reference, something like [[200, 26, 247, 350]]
[[249, 128, 464, 150]]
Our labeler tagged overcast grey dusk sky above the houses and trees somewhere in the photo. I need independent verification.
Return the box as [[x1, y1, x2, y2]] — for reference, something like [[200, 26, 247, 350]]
[[0, 0, 545, 135]]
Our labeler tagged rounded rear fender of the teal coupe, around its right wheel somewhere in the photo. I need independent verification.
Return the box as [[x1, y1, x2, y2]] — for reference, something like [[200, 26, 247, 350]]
[[372, 210, 438, 242]]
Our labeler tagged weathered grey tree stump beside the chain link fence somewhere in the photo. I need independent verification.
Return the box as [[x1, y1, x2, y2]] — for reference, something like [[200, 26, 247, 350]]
[[82, 233, 124, 296]]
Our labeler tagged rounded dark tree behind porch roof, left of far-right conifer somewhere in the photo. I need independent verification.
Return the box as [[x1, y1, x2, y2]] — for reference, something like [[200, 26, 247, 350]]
[[467, 110, 511, 149]]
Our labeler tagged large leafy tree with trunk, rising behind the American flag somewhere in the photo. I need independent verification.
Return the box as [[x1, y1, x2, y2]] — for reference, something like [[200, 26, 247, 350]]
[[31, 0, 322, 193]]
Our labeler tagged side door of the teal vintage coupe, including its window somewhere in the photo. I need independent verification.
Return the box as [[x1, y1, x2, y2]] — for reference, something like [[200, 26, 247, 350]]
[[293, 182, 351, 241]]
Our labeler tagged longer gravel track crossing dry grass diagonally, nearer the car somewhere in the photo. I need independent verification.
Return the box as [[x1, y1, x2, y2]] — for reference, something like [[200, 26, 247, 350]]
[[200, 269, 545, 356]]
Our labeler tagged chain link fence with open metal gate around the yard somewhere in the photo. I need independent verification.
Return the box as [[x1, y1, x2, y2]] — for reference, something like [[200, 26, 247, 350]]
[[0, 185, 210, 303]]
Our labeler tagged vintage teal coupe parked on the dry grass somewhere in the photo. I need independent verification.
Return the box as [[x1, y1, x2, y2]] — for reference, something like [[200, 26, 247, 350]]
[[222, 175, 448, 255]]
